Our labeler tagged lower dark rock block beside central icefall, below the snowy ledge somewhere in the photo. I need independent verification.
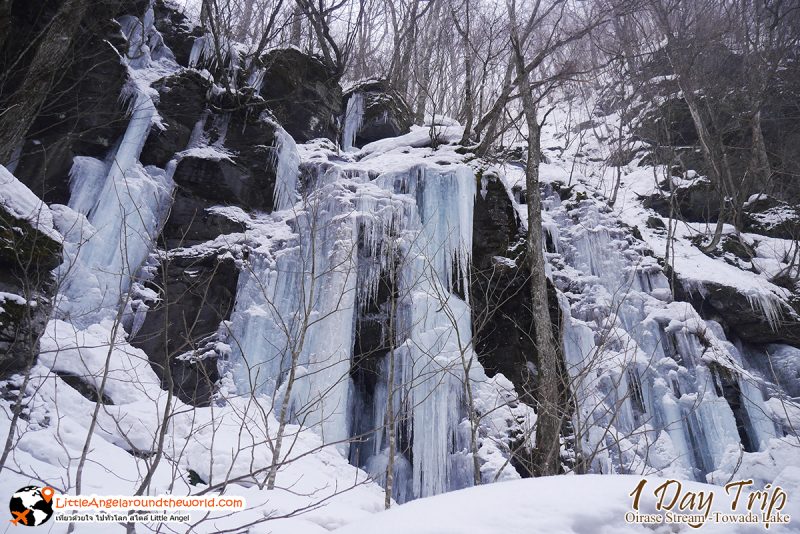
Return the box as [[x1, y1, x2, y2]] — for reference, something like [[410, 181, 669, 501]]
[[131, 251, 239, 404]]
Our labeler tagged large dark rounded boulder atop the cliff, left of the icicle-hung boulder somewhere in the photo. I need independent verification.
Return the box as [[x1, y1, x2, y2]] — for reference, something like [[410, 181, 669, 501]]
[[261, 48, 342, 143]]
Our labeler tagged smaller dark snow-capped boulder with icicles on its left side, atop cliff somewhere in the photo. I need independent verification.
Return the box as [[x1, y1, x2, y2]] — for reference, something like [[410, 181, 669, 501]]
[[342, 81, 414, 148]]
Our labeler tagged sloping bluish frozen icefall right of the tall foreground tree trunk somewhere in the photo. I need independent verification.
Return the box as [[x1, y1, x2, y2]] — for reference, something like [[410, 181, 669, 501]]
[[545, 192, 783, 480]]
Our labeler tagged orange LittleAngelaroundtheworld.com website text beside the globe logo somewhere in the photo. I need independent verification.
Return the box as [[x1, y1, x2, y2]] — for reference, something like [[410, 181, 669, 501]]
[[53, 495, 246, 511]]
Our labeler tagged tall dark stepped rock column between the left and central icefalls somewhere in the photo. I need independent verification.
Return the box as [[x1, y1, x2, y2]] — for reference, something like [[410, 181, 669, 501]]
[[138, 70, 294, 405]]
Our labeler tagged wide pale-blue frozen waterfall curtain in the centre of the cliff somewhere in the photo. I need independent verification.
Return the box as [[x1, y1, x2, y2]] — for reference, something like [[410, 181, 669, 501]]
[[231, 159, 485, 502]]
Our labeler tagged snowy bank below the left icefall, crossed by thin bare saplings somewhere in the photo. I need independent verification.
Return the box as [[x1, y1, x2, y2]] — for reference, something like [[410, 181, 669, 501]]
[[0, 356, 383, 534]]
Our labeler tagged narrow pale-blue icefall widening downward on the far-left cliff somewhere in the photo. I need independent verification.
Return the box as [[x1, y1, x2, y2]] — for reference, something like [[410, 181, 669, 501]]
[[58, 10, 172, 324]]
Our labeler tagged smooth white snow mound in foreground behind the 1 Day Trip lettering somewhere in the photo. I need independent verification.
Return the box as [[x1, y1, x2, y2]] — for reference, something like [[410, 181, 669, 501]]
[[335, 476, 800, 534]]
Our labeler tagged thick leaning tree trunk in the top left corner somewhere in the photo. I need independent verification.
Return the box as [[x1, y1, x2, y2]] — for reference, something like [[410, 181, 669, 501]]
[[0, 0, 89, 163]]
